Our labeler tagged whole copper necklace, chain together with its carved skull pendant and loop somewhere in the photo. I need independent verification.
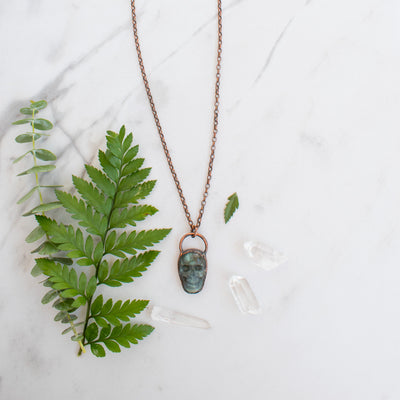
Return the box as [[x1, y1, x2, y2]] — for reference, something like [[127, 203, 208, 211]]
[[131, 0, 222, 293]]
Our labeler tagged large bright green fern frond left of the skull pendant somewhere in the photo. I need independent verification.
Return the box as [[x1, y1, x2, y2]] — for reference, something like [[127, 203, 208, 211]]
[[28, 127, 170, 357]]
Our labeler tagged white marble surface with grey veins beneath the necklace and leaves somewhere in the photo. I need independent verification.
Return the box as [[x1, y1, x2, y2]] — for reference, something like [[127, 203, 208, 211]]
[[0, 0, 400, 400]]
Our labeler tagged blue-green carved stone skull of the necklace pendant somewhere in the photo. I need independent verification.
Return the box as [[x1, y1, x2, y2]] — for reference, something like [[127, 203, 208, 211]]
[[178, 249, 207, 293]]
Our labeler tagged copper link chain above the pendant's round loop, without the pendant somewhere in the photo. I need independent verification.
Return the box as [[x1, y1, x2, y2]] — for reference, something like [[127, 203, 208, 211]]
[[131, 0, 222, 233]]
